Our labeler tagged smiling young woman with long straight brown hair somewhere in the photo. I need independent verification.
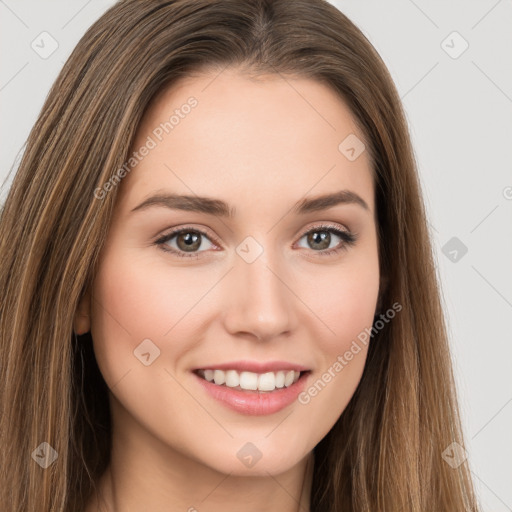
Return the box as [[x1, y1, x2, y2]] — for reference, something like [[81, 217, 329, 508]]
[[0, 0, 478, 512]]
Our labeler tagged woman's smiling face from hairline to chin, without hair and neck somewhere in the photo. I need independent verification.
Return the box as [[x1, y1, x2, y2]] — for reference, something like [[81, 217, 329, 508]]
[[76, 70, 379, 475]]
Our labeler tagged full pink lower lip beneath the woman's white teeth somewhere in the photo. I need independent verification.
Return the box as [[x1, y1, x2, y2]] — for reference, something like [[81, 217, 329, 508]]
[[194, 372, 309, 416]]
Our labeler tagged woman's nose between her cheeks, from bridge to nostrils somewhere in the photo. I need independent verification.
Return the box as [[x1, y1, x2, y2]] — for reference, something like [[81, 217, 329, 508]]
[[224, 253, 297, 341]]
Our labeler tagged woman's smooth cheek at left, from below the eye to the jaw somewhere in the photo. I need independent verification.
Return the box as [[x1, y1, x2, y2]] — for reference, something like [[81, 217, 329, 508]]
[[91, 249, 211, 432]]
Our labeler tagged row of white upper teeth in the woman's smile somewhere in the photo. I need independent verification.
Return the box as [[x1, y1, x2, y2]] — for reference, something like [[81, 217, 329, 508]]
[[199, 369, 300, 391]]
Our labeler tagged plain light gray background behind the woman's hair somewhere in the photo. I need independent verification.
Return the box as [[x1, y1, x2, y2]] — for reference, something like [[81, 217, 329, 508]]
[[0, 0, 512, 512]]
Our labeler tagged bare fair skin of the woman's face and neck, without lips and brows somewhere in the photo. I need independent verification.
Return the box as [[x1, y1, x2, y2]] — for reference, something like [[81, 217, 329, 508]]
[[75, 69, 379, 512]]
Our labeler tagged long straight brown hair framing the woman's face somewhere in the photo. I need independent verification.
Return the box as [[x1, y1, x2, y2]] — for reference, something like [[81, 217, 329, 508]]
[[0, 0, 477, 512]]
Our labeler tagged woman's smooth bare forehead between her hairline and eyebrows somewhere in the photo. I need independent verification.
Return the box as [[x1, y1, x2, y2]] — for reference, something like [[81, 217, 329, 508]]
[[116, 70, 373, 218]]
